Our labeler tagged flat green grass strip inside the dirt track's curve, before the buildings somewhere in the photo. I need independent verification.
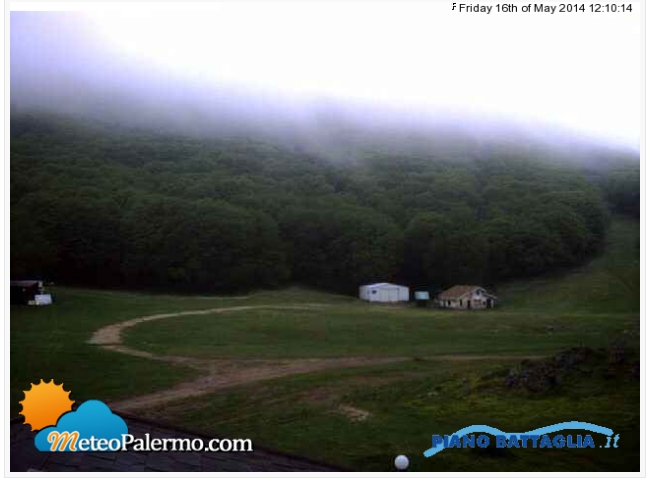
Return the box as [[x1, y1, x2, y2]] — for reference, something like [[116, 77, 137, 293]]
[[125, 304, 639, 359]]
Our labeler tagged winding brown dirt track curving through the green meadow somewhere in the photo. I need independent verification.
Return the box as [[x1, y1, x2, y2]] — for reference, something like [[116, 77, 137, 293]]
[[89, 304, 533, 412]]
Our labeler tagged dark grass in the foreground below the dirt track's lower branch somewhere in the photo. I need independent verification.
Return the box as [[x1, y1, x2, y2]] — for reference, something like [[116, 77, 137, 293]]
[[143, 354, 640, 471]]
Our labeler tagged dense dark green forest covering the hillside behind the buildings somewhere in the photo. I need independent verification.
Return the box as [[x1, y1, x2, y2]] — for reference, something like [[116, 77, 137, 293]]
[[11, 115, 639, 292]]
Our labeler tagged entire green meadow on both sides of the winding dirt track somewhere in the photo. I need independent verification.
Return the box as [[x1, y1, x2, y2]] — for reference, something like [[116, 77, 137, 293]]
[[11, 218, 640, 471]]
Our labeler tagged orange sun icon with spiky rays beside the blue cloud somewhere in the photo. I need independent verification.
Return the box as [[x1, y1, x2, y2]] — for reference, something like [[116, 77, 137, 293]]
[[19, 378, 74, 431]]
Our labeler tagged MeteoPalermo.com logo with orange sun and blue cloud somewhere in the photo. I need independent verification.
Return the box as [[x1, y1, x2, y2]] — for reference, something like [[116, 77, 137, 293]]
[[20, 380, 253, 452]]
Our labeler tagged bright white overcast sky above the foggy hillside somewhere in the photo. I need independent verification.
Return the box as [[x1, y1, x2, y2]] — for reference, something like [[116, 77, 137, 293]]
[[11, 2, 640, 149]]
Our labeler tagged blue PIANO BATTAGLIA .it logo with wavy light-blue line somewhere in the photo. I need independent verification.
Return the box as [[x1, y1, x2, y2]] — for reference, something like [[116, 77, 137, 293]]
[[424, 422, 619, 458]]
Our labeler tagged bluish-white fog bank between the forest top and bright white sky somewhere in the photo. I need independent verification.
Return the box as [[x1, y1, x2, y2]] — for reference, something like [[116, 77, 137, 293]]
[[10, 12, 637, 166]]
